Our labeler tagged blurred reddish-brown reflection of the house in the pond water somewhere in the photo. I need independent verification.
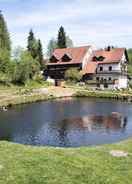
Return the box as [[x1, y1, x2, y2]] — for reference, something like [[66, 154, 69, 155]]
[[58, 113, 127, 132]]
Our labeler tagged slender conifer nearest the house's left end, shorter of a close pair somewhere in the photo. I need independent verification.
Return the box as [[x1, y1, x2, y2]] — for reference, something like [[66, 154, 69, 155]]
[[37, 39, 44, 68]]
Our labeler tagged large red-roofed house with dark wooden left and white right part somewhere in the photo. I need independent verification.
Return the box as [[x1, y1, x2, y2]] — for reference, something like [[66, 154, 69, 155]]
[[46, 46, 128, 88]]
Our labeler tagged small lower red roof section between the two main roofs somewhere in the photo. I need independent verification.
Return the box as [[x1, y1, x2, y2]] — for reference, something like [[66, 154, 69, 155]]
[[81, 62, 98, 75]]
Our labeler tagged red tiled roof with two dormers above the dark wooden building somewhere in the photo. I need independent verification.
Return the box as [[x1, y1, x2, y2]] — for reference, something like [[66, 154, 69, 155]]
[[48, 46, 91, 65]]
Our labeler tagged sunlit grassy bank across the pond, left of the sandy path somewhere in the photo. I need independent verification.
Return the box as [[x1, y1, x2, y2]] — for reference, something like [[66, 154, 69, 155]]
[[0, 80, 53, 107]]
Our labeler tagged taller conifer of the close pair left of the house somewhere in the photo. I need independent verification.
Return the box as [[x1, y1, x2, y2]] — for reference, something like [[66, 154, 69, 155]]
[[27, 29, 38, 59]]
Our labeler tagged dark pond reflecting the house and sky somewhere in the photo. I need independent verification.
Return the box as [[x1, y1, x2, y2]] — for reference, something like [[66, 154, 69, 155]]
[[0, 98, 132, 147]]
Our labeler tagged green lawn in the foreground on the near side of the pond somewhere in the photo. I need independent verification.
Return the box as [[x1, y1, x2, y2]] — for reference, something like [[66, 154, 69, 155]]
[[0, 139, 132, 184]]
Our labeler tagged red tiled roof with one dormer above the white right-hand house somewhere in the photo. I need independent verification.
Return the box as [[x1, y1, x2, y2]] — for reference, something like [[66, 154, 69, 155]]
[[93, 48, 125, 64]]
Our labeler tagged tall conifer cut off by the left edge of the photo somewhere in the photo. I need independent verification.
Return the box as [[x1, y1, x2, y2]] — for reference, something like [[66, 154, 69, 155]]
[[0, 11, 11, 57]]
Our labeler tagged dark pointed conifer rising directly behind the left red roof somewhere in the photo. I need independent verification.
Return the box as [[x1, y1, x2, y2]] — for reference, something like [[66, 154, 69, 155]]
[[57, 26, 67, 48]]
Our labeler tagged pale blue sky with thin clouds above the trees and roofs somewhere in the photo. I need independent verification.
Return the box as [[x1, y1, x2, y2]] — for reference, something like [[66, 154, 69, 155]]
[[0, 0, 132, 51]]
